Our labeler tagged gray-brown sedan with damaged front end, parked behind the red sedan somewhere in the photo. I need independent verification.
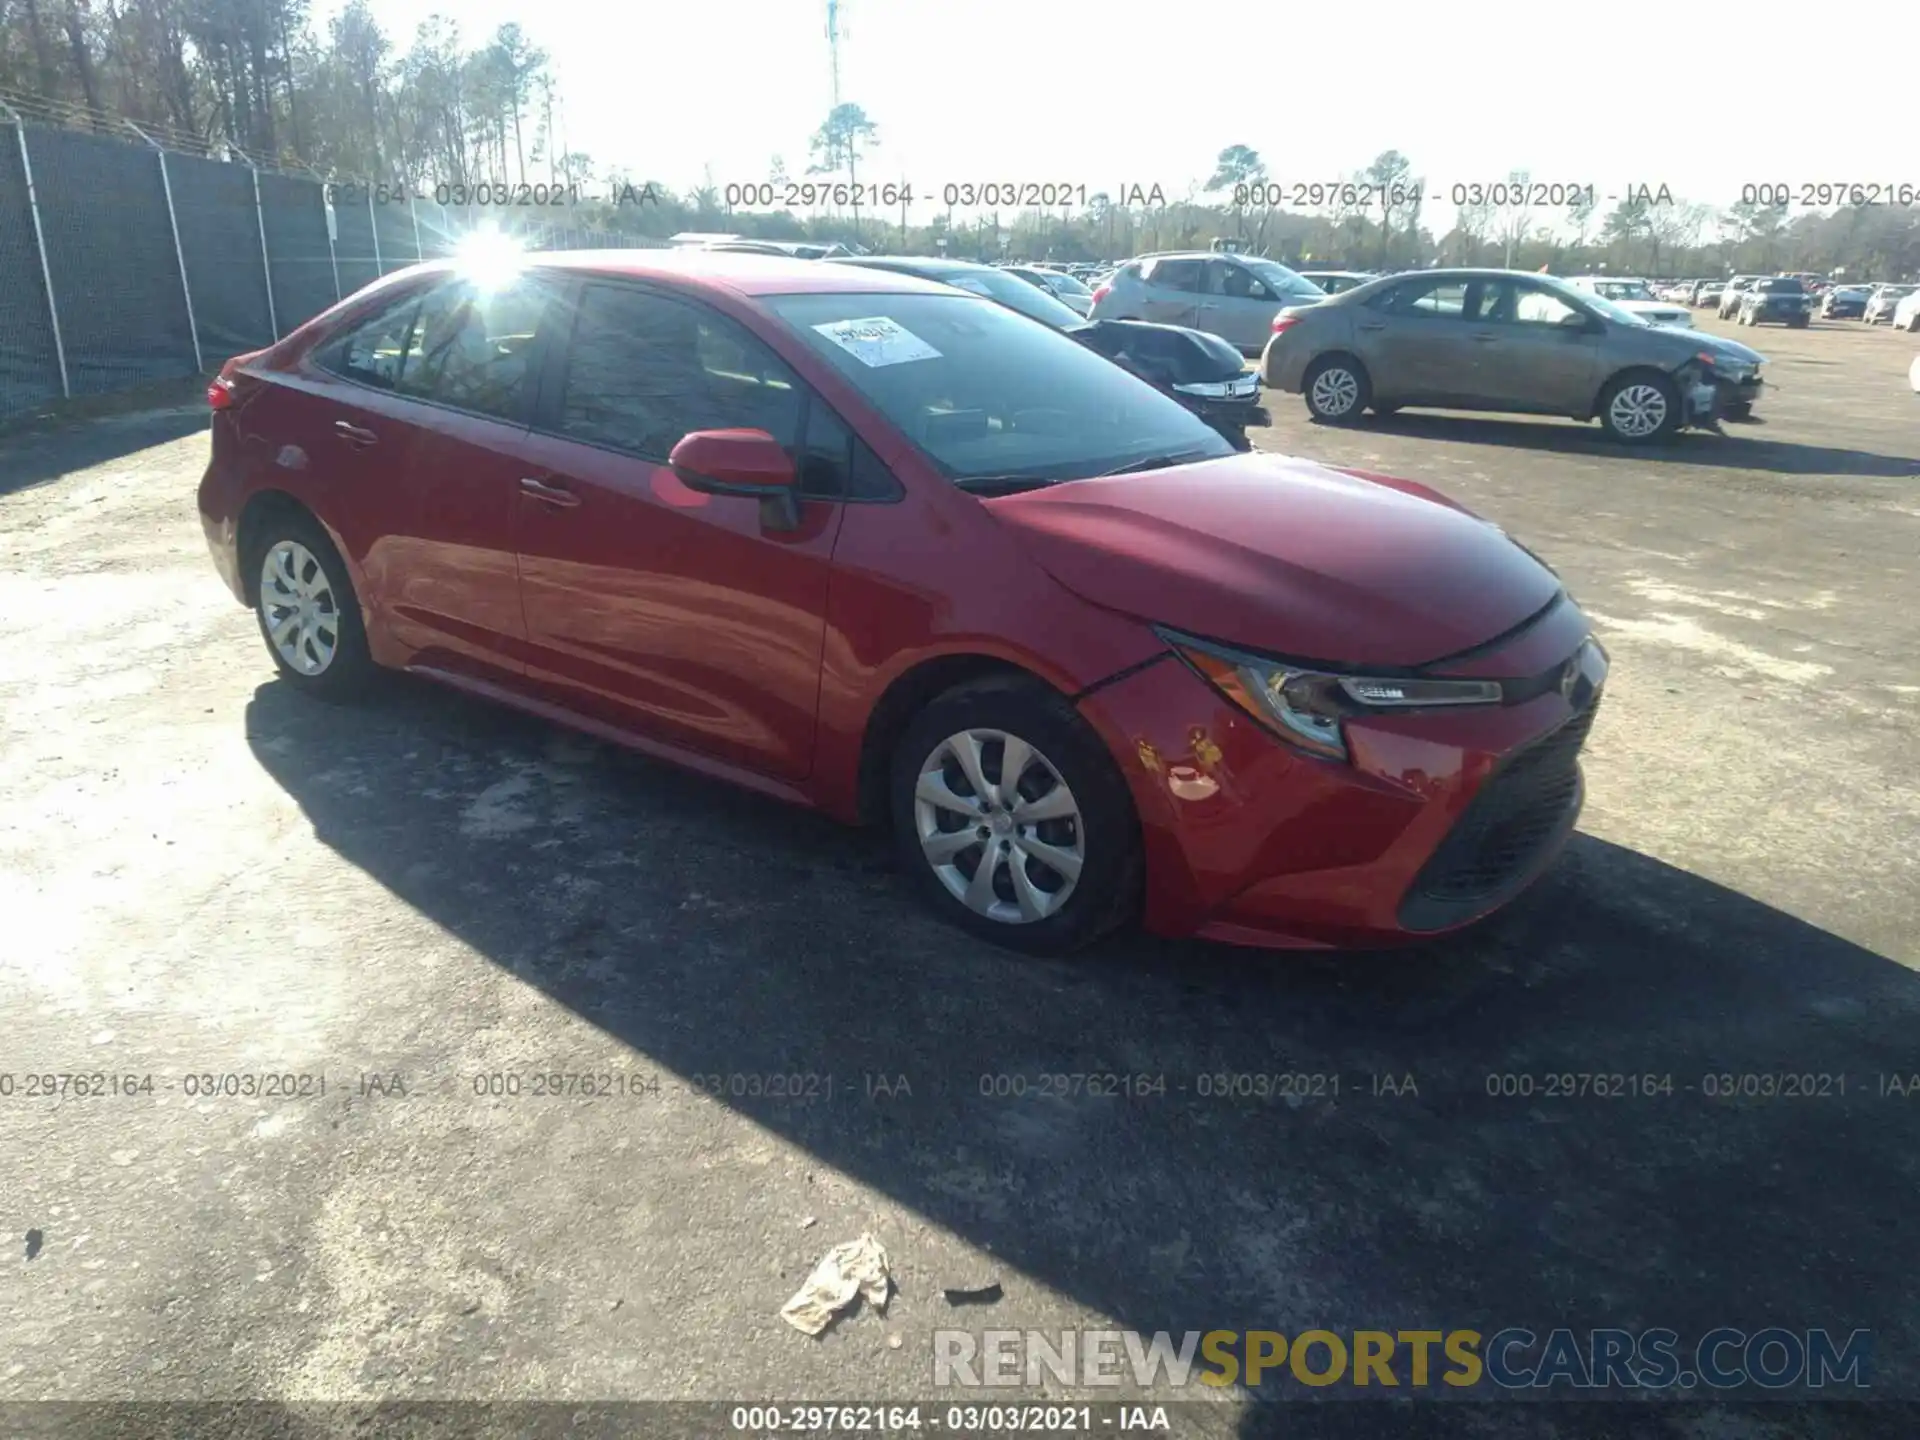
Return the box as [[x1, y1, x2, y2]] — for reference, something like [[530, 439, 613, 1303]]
[[1260, 271, 1763, 444]]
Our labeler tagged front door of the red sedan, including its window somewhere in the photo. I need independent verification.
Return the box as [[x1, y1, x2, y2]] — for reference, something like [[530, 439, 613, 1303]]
[[515, 280, 851, 780]]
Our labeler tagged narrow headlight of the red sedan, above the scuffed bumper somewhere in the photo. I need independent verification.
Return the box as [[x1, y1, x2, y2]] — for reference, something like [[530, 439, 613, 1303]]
[[1158, 630, 1501, 760]]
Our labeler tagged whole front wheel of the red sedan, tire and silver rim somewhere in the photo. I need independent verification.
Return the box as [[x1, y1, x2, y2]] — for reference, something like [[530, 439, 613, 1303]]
[[891, 678, 1142, 954]]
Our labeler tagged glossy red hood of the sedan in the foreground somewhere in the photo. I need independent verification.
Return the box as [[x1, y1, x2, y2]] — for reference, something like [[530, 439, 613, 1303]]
[[983, 453, 1561, 668]]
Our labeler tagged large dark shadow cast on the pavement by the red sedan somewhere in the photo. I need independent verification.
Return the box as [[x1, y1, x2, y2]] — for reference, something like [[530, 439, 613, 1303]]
[[246, 680, 1920, 1436]]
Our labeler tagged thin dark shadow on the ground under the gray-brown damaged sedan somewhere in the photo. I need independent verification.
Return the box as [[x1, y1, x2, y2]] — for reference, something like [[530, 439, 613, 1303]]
[[1305, 411, 1920, 478]]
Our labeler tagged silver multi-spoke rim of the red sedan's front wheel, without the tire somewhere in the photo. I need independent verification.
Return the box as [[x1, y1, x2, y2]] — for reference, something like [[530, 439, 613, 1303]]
[[914, 730, 1087, 925]]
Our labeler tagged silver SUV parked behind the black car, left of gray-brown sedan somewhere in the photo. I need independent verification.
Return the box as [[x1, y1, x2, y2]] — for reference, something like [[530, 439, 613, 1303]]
[[1092, 250, 1327, 355]]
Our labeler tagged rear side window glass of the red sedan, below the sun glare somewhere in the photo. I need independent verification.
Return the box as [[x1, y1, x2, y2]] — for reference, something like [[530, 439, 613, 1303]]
[[319, 278, 547, 420]]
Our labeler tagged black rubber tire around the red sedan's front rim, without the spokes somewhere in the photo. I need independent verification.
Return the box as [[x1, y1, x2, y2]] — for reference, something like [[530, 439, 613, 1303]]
[[887, 676, 1144, 954]]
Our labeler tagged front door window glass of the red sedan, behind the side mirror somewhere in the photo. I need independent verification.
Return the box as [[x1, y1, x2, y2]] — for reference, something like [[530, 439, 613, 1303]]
[[559, 284, 803, 461]]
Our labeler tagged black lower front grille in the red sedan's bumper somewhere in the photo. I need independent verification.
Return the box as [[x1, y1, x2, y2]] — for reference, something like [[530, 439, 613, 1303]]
[[1400, 703, 1599, 929]]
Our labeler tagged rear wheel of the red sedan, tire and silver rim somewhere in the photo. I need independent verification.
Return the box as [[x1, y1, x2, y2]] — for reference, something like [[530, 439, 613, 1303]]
[[248, 511, 376, 701]]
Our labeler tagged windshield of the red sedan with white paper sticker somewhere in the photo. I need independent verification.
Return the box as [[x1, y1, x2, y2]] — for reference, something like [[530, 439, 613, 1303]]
[[766, 289, 1233, 484]]
